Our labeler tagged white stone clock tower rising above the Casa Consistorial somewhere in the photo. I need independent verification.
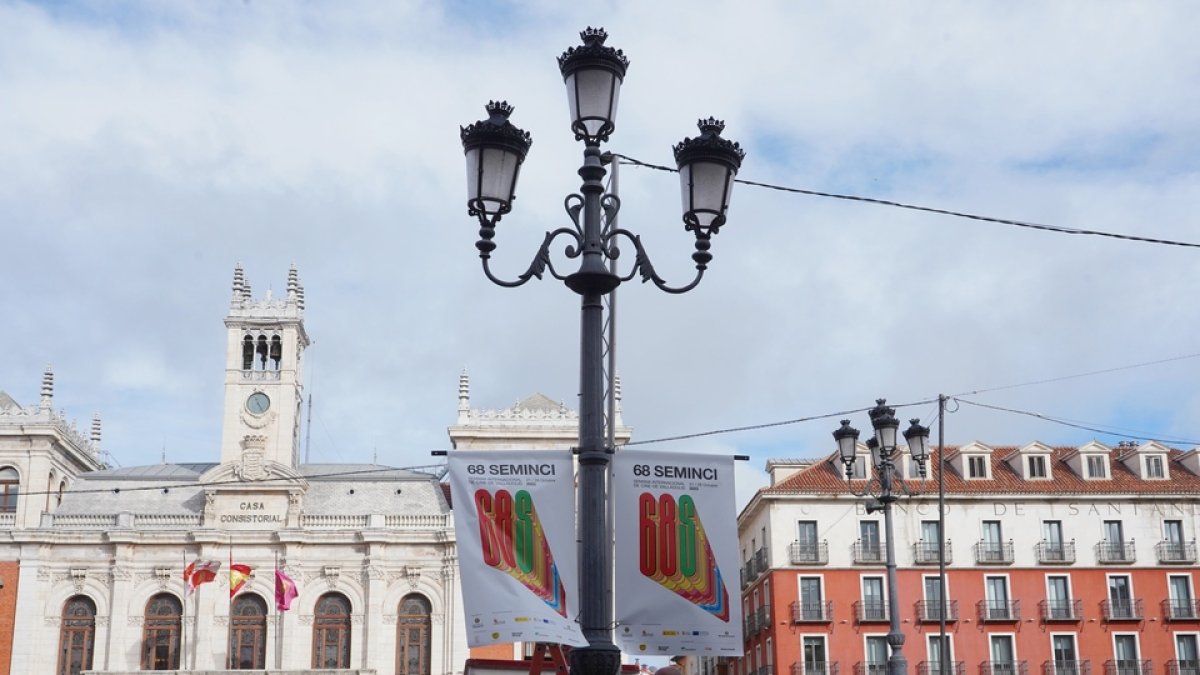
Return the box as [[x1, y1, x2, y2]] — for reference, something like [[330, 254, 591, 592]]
[[221, 263, 308, 468]]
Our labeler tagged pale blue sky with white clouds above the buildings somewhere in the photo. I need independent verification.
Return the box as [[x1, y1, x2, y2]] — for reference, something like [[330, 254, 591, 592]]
[[0, 0, 1200, 500]]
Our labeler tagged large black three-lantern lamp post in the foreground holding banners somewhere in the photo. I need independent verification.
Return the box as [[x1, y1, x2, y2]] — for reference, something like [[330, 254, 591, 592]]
[[461, 28, 745, 675]]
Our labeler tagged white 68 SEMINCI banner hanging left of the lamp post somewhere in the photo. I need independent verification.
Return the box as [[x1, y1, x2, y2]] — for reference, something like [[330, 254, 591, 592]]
[[448, 450, 588, 647]]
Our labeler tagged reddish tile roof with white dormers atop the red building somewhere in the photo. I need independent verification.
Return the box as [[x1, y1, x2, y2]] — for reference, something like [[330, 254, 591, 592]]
[[760, 446, 1200, 496]]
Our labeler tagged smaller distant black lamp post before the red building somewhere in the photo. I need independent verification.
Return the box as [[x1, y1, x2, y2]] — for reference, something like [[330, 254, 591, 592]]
[[833, 399, 944, 675]]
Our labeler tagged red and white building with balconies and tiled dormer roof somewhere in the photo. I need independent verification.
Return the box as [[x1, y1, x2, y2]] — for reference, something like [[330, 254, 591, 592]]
[[728, 442, 1200, 675]]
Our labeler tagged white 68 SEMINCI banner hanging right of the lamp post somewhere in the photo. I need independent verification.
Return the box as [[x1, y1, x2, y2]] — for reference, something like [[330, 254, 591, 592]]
[[612, 450, 743, 656]]
